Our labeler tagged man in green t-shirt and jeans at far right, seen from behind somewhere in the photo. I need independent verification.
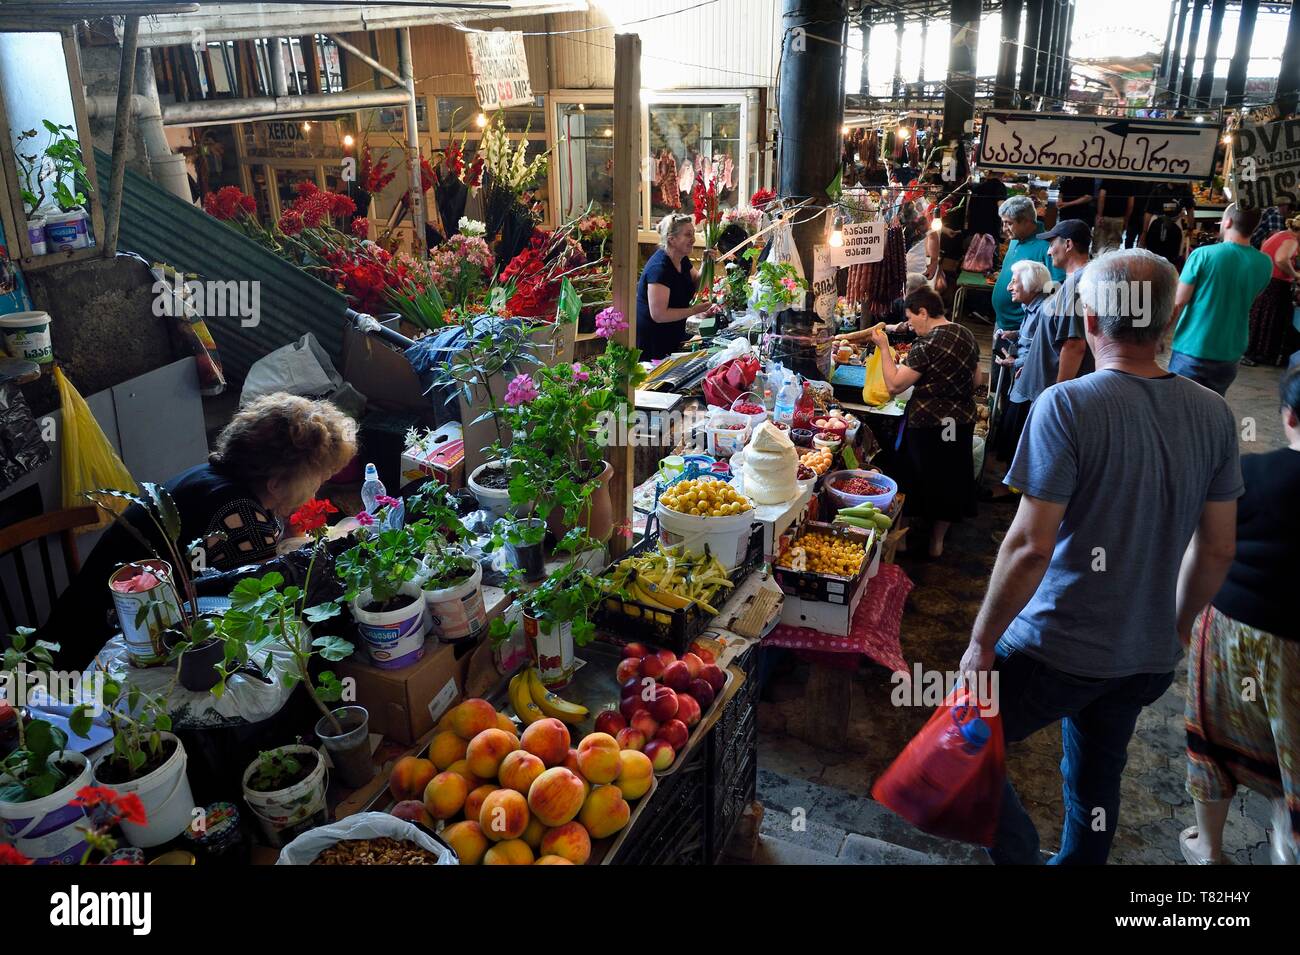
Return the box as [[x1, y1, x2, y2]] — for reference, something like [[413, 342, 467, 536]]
[[1169, 203, 1273, 395]]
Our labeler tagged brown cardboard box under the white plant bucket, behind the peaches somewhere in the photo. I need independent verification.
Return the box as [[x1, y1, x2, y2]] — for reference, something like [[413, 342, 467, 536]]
[[334, 639, 476, 745]]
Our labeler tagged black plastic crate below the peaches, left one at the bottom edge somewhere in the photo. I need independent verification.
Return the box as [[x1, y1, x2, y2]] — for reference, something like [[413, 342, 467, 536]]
[[614, 747, 709, 865]]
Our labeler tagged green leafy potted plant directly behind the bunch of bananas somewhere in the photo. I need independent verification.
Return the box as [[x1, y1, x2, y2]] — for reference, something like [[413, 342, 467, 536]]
[[490, 548, 608, 690]]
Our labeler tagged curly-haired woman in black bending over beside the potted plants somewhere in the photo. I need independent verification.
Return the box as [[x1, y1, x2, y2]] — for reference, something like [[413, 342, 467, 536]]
[[38, 392, 356, 668]]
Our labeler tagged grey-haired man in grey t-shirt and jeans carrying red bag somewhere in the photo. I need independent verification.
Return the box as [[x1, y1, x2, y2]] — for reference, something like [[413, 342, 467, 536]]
[[961, 249, 1243, 864]]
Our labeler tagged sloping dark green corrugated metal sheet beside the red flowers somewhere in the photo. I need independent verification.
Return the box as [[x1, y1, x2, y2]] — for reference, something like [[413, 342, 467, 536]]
[[95, 149, 347, 381]]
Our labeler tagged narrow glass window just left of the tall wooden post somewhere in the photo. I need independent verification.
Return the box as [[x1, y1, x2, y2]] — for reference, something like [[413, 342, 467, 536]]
[[550, 103, 614, 221]]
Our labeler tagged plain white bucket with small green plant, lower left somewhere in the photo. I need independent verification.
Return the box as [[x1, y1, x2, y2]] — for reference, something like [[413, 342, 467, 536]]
[[69, 672, 194, 848]]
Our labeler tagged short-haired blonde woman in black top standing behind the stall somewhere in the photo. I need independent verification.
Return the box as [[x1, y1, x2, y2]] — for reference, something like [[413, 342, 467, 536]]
[[637, 212, 711, 361]]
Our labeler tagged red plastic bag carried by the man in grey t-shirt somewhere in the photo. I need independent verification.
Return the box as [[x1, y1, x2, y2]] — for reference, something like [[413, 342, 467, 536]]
[[871, 686, 1006, 847]]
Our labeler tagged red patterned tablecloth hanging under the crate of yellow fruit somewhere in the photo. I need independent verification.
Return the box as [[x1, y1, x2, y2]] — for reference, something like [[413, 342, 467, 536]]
[[763, 564, 913, 672]]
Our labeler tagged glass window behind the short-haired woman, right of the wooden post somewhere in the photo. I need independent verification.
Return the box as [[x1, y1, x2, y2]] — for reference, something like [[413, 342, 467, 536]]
[[649, 103, 746, 222]]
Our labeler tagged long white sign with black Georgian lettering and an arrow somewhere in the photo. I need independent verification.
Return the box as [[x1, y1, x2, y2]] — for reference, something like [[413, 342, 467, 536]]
[[976, 110, 1222, 182]]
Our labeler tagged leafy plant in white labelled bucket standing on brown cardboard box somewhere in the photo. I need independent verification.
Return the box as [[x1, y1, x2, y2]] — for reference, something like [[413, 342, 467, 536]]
[[335, 499, 434, 669]]
